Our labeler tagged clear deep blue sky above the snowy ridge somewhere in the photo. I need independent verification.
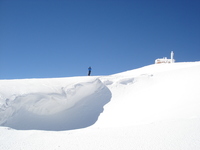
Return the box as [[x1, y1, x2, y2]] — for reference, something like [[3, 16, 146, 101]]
[[0, 0, 200, 79]]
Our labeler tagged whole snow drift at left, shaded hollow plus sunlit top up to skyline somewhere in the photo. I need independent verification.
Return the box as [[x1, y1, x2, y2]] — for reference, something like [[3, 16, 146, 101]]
[[0, 78, 111, 130]]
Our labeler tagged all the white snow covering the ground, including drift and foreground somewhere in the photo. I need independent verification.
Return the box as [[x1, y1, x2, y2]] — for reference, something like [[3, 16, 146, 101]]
[[0, 62, 200, 150]]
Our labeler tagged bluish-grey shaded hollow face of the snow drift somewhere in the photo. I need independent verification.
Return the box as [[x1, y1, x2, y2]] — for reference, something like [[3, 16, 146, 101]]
[[0, 79, 112, 131]]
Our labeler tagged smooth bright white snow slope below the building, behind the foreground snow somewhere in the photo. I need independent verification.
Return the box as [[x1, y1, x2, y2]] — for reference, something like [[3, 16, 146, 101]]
[[97, 62, 200, 126]]
